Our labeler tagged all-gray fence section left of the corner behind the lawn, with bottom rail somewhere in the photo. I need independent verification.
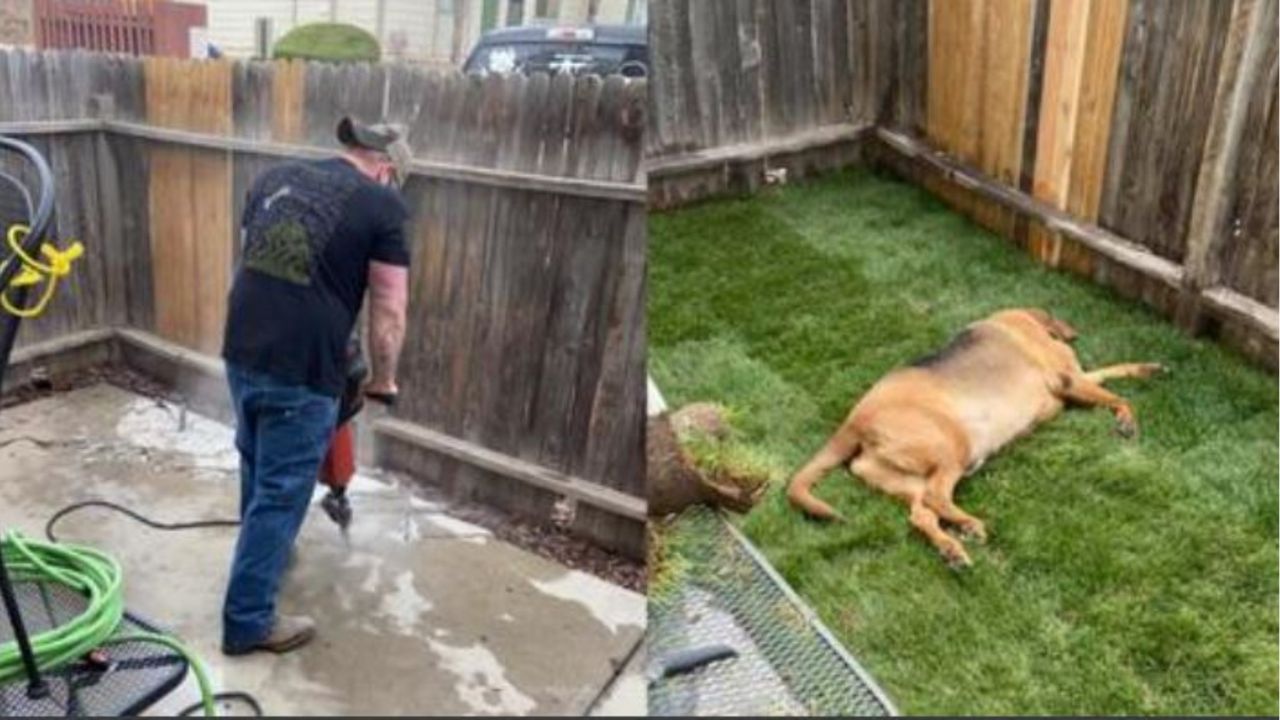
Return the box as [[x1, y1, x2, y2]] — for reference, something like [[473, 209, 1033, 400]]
[[646, 0, 925, 208]]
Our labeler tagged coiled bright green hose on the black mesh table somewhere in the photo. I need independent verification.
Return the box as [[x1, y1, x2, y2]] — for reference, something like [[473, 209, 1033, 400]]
[[0, 530, 216, 717]]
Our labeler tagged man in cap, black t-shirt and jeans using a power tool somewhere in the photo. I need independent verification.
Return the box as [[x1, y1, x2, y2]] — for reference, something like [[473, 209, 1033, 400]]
[[223, 118, 412, 655]]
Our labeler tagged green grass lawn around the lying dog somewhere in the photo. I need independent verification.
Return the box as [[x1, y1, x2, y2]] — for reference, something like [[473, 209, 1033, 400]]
[[649, 170, 1280, 715]]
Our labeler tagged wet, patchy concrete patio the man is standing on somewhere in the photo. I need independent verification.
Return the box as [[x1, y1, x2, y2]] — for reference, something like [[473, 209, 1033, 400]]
[[0, 384, 645, 715]]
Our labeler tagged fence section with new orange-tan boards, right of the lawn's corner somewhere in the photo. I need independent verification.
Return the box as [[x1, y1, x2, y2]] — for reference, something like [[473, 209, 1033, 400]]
[[881, 0, 1280, 368]]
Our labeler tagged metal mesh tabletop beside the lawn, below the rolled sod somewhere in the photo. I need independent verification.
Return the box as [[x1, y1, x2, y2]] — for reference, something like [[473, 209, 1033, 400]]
[[648, 507, 897, 716]]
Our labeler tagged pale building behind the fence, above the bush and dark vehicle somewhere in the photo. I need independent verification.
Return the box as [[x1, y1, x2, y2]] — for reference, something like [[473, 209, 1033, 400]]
[[193, 0, 648, 67]]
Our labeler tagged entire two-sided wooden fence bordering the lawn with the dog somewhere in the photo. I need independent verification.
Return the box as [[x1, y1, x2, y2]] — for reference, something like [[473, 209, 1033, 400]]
[[648, 0, 1280, 366]]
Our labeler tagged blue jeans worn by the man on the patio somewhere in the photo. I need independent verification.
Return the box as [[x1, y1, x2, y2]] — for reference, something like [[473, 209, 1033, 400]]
[[223, 364, 338, 651]]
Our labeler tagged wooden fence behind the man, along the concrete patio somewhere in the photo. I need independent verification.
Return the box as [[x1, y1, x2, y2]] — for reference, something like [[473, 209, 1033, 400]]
[[0, 53, 646, 552]]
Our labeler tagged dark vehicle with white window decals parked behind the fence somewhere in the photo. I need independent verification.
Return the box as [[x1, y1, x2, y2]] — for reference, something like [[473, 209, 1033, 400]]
[[462, 26, 649, 77]]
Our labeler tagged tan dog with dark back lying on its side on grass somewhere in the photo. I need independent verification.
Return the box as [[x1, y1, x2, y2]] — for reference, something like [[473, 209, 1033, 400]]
[[787, 309, 1162, 566]]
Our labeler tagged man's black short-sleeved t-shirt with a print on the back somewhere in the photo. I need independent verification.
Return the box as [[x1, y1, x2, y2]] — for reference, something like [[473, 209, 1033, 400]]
[[223, 159, 408, 396]]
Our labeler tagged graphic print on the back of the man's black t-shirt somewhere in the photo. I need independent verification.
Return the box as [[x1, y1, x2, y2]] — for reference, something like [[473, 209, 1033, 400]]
[[244, 164, 360, 286]]
